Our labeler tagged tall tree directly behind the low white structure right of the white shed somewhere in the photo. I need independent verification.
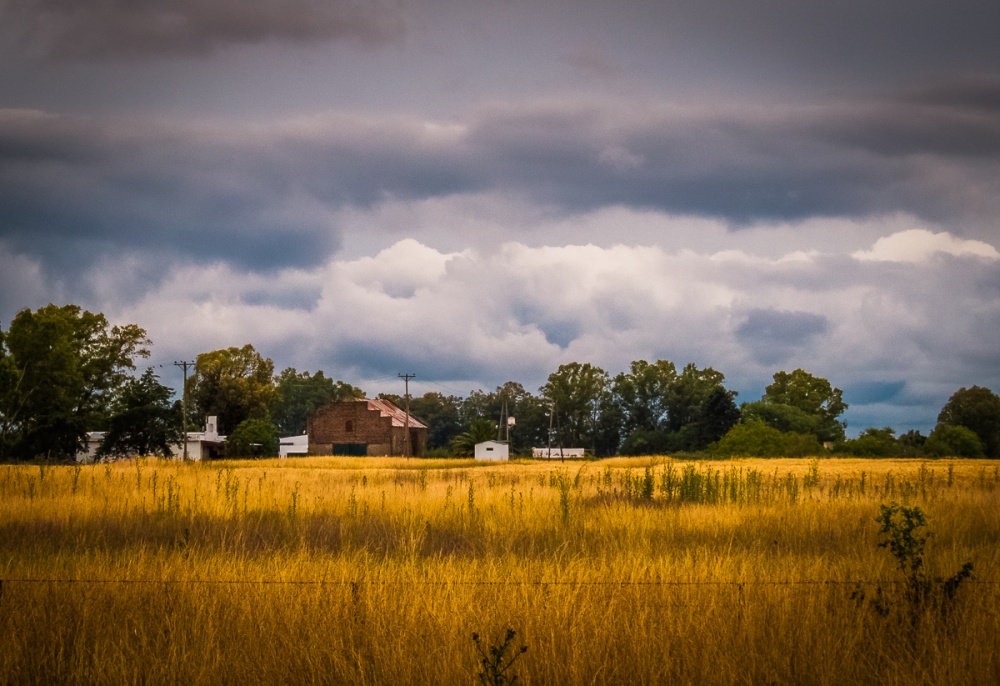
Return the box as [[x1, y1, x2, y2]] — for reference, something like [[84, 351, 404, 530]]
[[541, 362, 617, 449]]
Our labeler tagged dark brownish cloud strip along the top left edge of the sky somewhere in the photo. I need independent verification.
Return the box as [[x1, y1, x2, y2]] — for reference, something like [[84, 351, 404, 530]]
[[0, 0, 402, 58]]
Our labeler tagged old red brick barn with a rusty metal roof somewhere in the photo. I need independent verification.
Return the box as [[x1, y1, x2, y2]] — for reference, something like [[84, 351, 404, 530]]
[[306, 398, 427, 457]]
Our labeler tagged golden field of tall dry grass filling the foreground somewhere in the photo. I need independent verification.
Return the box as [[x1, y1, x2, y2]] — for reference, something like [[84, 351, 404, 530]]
[[0, 458, 1000, 684]]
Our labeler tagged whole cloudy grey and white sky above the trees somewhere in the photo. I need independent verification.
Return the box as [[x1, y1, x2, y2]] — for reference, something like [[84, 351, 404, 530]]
[[0, 0, 1000, 435]]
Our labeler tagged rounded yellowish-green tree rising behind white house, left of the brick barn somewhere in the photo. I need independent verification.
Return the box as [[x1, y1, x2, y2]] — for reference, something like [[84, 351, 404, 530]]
[[188, 343, 275, 434]]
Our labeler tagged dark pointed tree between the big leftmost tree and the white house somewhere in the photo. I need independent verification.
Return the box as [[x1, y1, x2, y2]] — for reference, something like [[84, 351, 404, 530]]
[[97, 369, 182, 457]]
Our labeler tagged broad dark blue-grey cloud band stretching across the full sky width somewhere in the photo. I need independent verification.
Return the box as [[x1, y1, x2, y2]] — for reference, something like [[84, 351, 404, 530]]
[[0, 79, 1000, 284]]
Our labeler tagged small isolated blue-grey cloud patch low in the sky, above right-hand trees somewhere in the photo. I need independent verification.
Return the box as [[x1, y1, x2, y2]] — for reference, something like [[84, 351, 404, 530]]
[[735, 310, 830, 365]]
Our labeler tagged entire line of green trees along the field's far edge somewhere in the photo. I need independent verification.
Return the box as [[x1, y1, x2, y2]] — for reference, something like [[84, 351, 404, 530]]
[[0, 305, 1000, 460]]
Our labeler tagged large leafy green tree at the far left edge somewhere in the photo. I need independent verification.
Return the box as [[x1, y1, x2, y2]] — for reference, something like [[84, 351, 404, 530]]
[[0, 305, 149, 459]]
